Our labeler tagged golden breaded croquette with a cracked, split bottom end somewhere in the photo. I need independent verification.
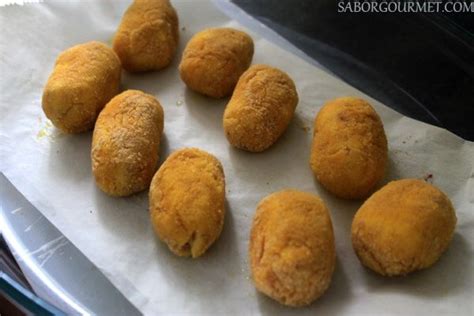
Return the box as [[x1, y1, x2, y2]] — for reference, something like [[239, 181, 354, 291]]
[[149, 148, 225, 258]]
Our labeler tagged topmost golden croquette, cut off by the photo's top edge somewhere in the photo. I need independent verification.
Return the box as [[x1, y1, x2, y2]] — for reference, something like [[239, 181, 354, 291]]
[[113, 0, 179, 72]]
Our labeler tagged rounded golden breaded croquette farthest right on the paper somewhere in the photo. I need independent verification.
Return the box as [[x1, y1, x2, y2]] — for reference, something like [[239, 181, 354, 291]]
[[352, 179, 456, 276]]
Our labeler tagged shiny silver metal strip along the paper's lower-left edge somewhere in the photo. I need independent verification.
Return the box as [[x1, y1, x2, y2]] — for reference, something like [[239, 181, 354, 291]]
[[0, 173, 141, 315]]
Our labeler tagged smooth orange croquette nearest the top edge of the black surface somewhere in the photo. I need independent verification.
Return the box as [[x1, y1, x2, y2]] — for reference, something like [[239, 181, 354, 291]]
[[179, 28, 254, 98]]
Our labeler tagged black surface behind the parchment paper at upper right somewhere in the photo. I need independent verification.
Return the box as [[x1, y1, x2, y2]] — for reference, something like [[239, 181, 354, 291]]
[[233, 0, 474, 140]]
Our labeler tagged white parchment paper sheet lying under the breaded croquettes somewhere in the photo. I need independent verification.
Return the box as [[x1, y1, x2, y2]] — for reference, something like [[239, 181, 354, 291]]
[[0, 1, 474, 315]]
